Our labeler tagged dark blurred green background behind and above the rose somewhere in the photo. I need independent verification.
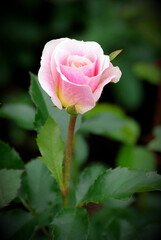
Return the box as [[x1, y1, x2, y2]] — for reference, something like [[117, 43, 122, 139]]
[[0, 0, 161, 168]]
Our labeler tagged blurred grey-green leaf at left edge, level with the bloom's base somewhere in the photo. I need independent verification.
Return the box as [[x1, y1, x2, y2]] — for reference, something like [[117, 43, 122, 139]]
[[0, 103, 35, 130]]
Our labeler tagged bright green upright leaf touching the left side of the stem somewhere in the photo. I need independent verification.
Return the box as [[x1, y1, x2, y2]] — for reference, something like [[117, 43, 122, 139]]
[[37, 117, 64, 187]]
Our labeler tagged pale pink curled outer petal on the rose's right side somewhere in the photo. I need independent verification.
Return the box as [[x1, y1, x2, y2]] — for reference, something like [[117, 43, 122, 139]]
[[93, 63, 122, 101]]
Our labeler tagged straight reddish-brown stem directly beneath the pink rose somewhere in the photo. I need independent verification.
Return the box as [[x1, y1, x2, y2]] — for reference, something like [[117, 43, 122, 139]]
[[63, 115, 77, 208]]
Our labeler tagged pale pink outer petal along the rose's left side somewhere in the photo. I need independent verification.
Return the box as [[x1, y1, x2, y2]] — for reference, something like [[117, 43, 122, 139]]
[[38, 38, 66, 109]]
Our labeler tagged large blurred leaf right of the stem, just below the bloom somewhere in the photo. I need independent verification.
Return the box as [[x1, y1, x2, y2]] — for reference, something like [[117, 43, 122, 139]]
[[79, 104, 140, 144]]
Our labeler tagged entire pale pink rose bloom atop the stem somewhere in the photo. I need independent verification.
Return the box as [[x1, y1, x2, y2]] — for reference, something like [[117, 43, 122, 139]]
[[38, 38, 121, 114]]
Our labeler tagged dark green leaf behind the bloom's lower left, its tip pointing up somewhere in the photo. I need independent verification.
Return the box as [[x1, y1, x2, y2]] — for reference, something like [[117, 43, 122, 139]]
[[30, 73, 81, 143]]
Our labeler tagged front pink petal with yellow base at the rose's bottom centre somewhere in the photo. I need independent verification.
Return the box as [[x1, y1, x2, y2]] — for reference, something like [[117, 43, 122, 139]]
[[59, 70, 95, 114]]
